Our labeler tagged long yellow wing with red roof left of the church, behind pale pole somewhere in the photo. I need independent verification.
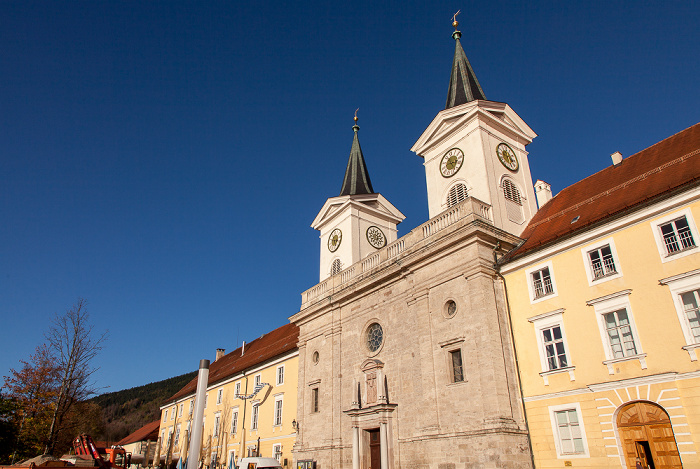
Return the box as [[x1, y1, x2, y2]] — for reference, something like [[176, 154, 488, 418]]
[[157, 324, 299, 468]]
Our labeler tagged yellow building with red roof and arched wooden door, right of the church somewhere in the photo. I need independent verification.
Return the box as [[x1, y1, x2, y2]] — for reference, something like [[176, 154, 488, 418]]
[[501, 124, 700, 469]]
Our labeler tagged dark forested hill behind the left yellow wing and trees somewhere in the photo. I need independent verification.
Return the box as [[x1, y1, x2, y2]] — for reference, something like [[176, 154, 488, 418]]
[[90, 371, 197, 442]]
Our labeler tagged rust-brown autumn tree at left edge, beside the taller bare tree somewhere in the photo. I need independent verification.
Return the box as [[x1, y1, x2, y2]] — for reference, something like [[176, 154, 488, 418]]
[[4, 345, 61, 460]]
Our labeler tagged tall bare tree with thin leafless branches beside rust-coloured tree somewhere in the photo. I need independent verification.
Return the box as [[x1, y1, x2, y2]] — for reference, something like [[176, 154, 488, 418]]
[[44, 298, 107, 453]]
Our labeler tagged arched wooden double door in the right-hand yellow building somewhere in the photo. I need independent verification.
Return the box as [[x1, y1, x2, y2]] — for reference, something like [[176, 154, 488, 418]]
[[617, 402, 683, 469]]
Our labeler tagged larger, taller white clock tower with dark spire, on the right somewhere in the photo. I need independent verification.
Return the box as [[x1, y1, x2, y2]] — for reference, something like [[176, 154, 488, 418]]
[[411, 15, 537, 235]]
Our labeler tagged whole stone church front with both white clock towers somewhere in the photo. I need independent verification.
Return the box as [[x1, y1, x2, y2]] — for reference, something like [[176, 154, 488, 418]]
[[290, 23, 536, 469]]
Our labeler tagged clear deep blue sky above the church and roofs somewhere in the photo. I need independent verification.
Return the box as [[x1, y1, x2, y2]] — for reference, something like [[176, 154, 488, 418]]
[[0, 0, 700, 391]]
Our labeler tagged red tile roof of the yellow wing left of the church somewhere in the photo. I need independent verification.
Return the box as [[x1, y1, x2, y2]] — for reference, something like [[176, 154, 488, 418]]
[[165, 324, 299, 403]]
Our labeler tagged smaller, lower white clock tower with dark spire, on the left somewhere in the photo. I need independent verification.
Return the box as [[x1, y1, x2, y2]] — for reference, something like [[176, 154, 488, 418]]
[[311, 112, 406, 282]]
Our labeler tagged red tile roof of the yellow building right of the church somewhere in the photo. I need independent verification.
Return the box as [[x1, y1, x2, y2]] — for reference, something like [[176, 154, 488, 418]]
[[508, 123, 700, 260]]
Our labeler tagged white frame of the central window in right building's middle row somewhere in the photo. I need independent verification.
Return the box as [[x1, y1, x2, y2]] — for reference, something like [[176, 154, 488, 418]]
[[586, 290, 647, 375]]
